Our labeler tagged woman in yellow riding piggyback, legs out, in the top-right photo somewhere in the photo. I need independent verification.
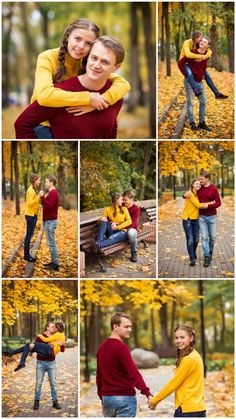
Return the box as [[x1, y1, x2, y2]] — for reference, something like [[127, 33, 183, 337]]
[[179, 30, 228, 99]]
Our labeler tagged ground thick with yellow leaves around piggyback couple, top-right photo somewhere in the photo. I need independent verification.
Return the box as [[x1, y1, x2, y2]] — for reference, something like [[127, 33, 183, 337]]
[[158, 61, 234, 139]]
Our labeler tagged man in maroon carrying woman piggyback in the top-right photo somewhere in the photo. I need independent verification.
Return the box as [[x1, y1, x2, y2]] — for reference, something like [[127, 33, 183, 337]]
[[178, 36, 211, 131]]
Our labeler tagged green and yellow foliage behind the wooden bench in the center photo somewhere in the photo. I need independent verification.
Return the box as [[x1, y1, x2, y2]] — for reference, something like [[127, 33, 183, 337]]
[[80, 141, 156, 212]]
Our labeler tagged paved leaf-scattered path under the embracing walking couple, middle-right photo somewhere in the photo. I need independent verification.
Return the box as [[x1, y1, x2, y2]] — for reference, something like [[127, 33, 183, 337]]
[[158, 198, 234, 279]]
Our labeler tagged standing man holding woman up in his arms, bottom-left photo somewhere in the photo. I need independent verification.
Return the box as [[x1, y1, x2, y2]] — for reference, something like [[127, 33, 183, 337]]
[[33, 321, 65, 410]]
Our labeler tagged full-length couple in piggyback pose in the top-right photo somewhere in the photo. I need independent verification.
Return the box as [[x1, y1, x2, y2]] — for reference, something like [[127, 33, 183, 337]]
[[178, 30, 228, 131]]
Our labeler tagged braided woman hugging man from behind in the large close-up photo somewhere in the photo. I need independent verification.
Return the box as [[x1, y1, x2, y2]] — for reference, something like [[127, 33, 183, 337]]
[[31, 19, 130, 139]]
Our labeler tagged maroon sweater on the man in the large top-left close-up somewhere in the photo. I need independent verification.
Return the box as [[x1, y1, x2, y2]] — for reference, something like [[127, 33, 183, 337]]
[[15, 77, 122, 139]]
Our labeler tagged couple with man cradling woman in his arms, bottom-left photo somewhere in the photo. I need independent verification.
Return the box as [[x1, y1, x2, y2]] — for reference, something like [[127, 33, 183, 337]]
[[3, 321, 65, 410]]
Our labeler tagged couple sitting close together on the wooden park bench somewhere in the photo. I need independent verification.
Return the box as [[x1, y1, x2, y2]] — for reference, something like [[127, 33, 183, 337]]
[[92, 190, 140, 262]]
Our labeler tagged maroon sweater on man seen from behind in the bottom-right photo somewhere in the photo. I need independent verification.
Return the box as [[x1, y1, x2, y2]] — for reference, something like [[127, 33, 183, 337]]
[[96, 338, 151, 399]]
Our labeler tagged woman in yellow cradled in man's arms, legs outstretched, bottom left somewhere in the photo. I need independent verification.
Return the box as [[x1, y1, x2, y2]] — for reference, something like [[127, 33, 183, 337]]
[[3, 322, 65, 371]]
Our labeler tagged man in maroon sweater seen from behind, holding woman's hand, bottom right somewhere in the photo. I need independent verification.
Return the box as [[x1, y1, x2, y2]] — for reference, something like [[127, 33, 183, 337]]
[[96, 312, 151, 417]]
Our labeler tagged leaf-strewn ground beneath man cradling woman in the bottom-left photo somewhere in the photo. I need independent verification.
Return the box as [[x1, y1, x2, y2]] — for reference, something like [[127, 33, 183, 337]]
[[2, 348, 78, 418]]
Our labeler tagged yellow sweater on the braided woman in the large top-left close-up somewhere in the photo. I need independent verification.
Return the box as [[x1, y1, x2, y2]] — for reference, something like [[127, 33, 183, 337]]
[[31, 48, 130, 108]]
